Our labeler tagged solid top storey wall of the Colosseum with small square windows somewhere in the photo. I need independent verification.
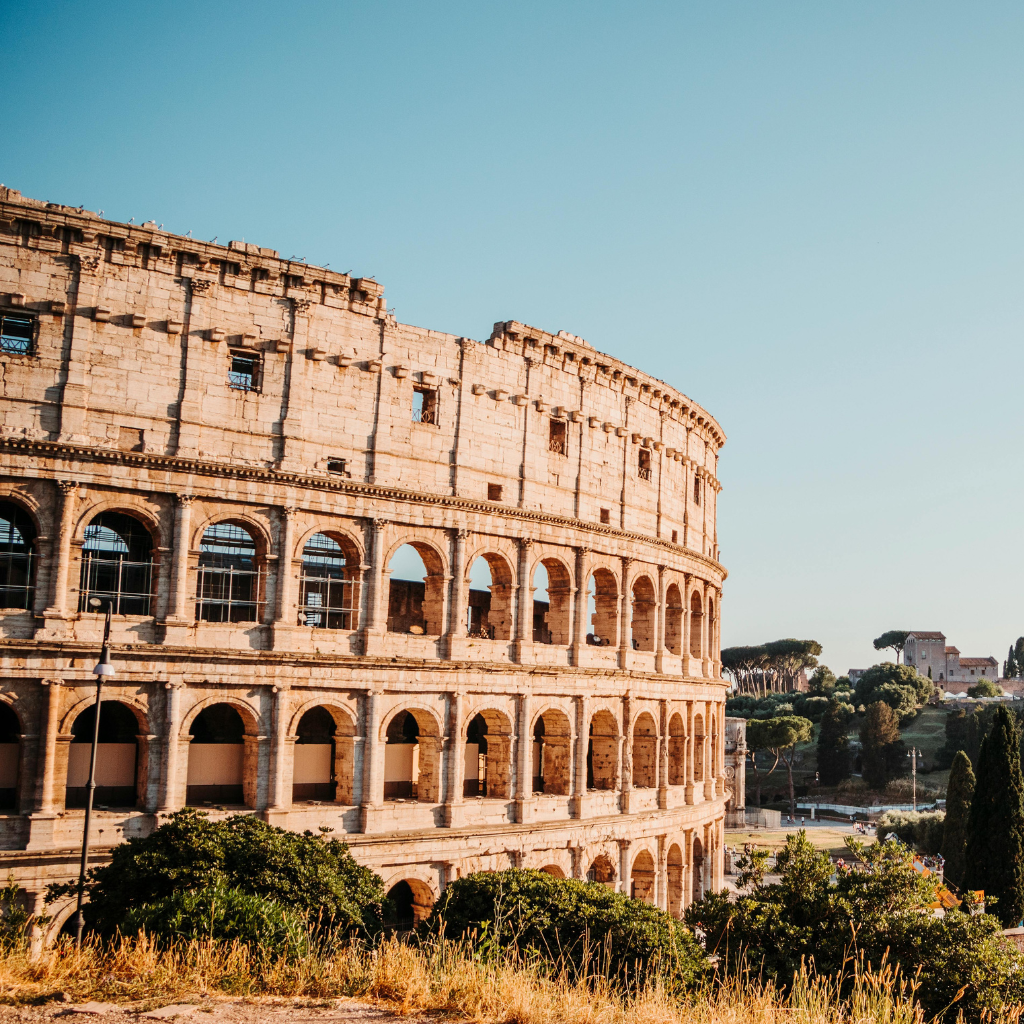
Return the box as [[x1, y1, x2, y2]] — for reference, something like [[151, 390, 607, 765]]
[[0, 188, 725, 560]]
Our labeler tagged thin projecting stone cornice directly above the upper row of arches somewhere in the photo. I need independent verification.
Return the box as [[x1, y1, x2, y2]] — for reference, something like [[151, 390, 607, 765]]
[[0, 437, 728, 583]]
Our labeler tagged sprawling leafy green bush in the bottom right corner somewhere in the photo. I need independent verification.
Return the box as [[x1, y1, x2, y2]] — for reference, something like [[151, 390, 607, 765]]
[[686, 831, 1024, 1022]]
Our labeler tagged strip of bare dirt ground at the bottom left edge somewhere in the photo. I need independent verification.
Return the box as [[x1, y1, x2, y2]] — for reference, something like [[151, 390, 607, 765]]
[[0, 996, 403, 1024]]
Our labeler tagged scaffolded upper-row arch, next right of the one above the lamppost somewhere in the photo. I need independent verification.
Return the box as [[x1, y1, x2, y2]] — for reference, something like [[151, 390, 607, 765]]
[[196, 522, 264, 623]]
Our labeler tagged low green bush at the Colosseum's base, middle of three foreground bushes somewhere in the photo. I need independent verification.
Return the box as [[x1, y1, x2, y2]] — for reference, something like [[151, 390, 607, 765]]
[[424, 868, 707, 986]]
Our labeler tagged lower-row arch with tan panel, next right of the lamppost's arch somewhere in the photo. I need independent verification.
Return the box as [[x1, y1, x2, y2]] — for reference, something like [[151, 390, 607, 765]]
[[185, 703, 250, 807]]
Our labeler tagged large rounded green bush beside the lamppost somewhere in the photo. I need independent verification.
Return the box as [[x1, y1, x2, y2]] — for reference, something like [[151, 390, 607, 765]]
[[47, 810, 384, 938]]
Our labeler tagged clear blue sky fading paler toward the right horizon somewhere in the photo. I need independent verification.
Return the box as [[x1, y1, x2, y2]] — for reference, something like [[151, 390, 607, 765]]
[[0, 0, 1024, 672]]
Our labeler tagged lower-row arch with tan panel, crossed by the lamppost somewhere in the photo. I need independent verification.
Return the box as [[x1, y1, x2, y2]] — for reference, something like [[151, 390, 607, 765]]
[[65, 700, 138, 807]]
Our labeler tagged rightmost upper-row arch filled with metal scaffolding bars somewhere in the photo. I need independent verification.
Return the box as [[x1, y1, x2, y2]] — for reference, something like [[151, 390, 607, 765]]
[[299, 534, 359, 630]]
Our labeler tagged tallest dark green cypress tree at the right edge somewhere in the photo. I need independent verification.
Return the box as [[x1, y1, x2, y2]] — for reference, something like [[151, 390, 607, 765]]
[[964, 707, 1024, 928]]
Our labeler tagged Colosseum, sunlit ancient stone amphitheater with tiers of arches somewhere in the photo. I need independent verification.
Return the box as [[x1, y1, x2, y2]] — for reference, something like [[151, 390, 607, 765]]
[[0, 187, 732, 936]]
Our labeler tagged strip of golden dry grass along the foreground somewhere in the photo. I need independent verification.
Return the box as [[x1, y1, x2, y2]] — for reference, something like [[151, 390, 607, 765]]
[[0, 937, 950, 1024]]
